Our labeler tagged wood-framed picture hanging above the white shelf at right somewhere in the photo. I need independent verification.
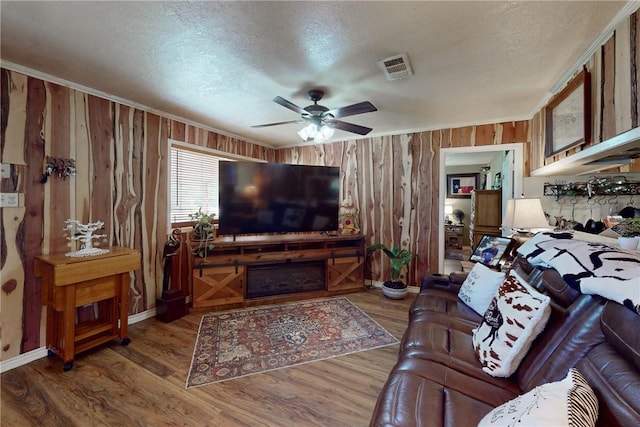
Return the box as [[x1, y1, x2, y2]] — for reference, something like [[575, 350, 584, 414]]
[[544, 69, 591, 157]]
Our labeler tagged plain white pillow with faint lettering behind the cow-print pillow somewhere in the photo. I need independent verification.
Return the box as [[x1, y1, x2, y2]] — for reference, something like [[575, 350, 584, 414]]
[[458, 262, 505, 315]]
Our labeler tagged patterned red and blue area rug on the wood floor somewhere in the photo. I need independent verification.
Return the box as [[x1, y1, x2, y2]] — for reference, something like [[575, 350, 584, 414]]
[[182, 298, 398, 388]]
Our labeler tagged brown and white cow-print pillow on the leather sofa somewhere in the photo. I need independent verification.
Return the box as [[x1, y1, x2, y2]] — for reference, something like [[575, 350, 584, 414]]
[[473, 274, 551, 377]]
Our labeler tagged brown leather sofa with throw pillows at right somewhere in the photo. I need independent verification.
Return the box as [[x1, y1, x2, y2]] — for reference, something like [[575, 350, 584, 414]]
[[370, 259, 640, 427]]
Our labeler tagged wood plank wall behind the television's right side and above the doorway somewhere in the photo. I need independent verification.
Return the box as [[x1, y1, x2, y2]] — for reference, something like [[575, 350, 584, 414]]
[[276, 120, 530, 285]]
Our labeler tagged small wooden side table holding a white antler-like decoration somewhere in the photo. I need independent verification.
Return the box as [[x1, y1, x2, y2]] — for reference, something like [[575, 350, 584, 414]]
[[35, 246, 140, 371]]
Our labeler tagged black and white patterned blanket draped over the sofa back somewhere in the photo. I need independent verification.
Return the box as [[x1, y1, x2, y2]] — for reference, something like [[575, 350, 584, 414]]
[[517, 232, 640, 314]]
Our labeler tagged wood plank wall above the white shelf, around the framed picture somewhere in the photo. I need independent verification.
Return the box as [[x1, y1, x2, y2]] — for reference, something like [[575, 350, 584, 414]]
[[531, 12, 640, 173]]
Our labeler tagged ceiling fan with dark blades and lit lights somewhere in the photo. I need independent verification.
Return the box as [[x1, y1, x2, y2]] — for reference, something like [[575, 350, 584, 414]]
[[251, 89, 378, 143]]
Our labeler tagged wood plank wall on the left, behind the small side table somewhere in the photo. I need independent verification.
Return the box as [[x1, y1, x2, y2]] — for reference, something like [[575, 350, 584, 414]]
[[0, 69, 275, 360]]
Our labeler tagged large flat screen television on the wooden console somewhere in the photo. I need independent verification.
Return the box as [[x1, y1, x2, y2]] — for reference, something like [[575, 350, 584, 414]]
[[218, 161, 340, 235]]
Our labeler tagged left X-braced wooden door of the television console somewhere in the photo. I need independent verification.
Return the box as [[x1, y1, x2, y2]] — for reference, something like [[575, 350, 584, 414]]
[[192, 265, 245, 308]]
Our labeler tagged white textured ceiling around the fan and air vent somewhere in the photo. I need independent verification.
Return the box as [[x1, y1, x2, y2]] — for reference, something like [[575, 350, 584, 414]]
[[0, 1, 640, 147]]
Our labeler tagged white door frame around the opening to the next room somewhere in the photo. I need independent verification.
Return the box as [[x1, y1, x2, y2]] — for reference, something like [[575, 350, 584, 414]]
[[438, 142, 525, 271]]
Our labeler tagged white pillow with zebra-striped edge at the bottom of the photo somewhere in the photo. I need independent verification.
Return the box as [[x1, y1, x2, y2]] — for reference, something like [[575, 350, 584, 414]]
[[478, 368, 598, 427]]
